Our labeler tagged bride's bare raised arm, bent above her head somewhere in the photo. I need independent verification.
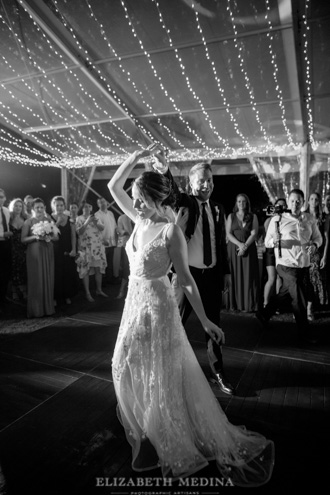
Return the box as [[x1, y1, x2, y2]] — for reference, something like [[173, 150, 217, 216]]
[[108, 144, 159, 222]]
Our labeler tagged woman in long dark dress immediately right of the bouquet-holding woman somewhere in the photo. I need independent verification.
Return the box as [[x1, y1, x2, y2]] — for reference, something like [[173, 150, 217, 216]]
[[51, 196, 77, 304]]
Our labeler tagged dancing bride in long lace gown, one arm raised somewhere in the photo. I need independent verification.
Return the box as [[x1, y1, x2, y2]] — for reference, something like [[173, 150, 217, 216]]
[[108, 145, 274, 486]]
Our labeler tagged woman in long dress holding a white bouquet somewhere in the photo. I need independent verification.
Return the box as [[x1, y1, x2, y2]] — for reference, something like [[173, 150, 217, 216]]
[[21, 198, 58, 318]]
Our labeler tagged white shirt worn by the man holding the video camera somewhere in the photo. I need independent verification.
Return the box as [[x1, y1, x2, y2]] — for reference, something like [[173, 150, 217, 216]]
[[265, 212, 322, 268]]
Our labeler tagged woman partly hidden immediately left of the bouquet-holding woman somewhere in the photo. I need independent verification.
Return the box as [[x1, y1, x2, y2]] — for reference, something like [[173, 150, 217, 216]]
[[8, 198, 27, 301]]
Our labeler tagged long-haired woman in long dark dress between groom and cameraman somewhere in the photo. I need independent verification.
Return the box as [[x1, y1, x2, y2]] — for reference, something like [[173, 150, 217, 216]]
[[226, 194, 260, 312]]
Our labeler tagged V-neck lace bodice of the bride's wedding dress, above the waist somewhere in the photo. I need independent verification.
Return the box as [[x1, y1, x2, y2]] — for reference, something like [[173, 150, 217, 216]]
[[126, 222, 172, 279]]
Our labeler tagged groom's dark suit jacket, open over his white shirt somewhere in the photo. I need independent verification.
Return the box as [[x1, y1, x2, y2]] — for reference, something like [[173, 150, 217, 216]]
[[164, 170, 230, 288]]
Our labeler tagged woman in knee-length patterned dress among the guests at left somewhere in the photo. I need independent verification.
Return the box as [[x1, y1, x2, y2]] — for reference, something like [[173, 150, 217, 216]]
[[76, 201, 108, 302]]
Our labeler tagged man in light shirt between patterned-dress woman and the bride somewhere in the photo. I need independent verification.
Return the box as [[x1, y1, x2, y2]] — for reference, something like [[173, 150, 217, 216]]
[[95, 198, 117, 282]]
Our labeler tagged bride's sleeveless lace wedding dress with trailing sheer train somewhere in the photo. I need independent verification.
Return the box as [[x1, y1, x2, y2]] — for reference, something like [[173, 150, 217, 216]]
[[112, 223, 274, 486]]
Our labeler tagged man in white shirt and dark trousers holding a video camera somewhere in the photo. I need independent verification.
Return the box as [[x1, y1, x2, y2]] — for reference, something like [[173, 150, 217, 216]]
[[256, 189, 322, 343]]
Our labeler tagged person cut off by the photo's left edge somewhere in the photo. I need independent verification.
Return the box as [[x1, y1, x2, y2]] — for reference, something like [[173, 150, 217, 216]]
[[0, 189, 13, 313]]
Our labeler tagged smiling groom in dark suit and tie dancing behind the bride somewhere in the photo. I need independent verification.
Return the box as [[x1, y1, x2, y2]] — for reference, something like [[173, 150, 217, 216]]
[[154, 158, 234, 394]]
